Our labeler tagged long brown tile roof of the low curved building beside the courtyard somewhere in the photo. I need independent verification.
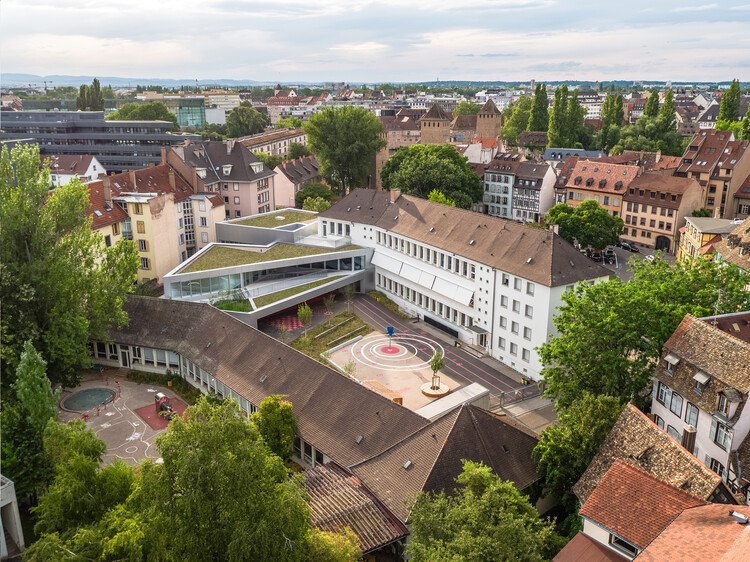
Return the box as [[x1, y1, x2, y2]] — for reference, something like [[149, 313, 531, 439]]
[[111, 295, 429, 467]]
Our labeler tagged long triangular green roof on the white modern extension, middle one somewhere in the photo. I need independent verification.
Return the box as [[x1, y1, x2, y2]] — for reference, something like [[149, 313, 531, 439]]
[[178, 244, 359, 273]]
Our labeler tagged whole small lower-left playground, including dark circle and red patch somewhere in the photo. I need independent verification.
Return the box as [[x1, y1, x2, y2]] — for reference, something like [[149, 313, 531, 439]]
[[59, 369, 186, 465]]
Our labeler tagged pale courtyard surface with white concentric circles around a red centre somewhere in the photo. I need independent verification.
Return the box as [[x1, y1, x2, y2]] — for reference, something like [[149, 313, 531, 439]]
[[328, 332, 461, 410]]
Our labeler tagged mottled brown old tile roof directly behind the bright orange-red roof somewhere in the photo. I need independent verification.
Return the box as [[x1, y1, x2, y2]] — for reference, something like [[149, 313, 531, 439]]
[[573, 404, 734, 503]]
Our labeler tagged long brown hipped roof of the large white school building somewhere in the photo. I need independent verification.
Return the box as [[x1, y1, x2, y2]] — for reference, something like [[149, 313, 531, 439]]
[[320, 189, 611, 287]]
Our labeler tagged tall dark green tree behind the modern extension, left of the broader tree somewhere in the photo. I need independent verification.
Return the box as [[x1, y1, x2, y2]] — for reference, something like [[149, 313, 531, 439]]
[[305, 105, 386, 195]]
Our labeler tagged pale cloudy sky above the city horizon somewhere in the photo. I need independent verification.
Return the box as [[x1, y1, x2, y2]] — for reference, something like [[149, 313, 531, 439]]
[[0, 0, 750, 82]]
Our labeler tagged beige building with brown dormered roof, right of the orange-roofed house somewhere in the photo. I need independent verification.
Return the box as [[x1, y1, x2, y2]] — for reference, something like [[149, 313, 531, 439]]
[[622, 168, 701, 254]]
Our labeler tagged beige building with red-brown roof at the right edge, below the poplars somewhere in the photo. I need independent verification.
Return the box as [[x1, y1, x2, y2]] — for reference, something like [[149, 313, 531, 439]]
[[674, 129, 750, 219]]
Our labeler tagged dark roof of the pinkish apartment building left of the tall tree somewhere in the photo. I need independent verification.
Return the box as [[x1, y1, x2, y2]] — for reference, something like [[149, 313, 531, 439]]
[[173, 139, 274, 185]]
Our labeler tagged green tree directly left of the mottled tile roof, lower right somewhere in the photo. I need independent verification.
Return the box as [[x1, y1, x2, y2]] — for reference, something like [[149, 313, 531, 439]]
[[533, 392, 623, 513]]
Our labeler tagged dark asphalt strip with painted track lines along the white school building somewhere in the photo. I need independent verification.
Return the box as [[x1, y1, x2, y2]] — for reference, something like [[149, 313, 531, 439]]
[[352, 295, 521, 394]]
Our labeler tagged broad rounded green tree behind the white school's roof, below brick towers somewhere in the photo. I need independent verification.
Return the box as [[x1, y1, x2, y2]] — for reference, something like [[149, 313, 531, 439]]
[[380, 144, 483, 209]]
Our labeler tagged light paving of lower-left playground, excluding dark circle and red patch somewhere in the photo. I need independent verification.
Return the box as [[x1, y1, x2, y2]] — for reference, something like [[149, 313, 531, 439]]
[[59, 369, 185, 465]]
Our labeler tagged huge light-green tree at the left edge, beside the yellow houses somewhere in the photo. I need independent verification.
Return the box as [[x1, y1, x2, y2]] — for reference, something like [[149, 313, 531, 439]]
[[0, 145, 139, 385]]
